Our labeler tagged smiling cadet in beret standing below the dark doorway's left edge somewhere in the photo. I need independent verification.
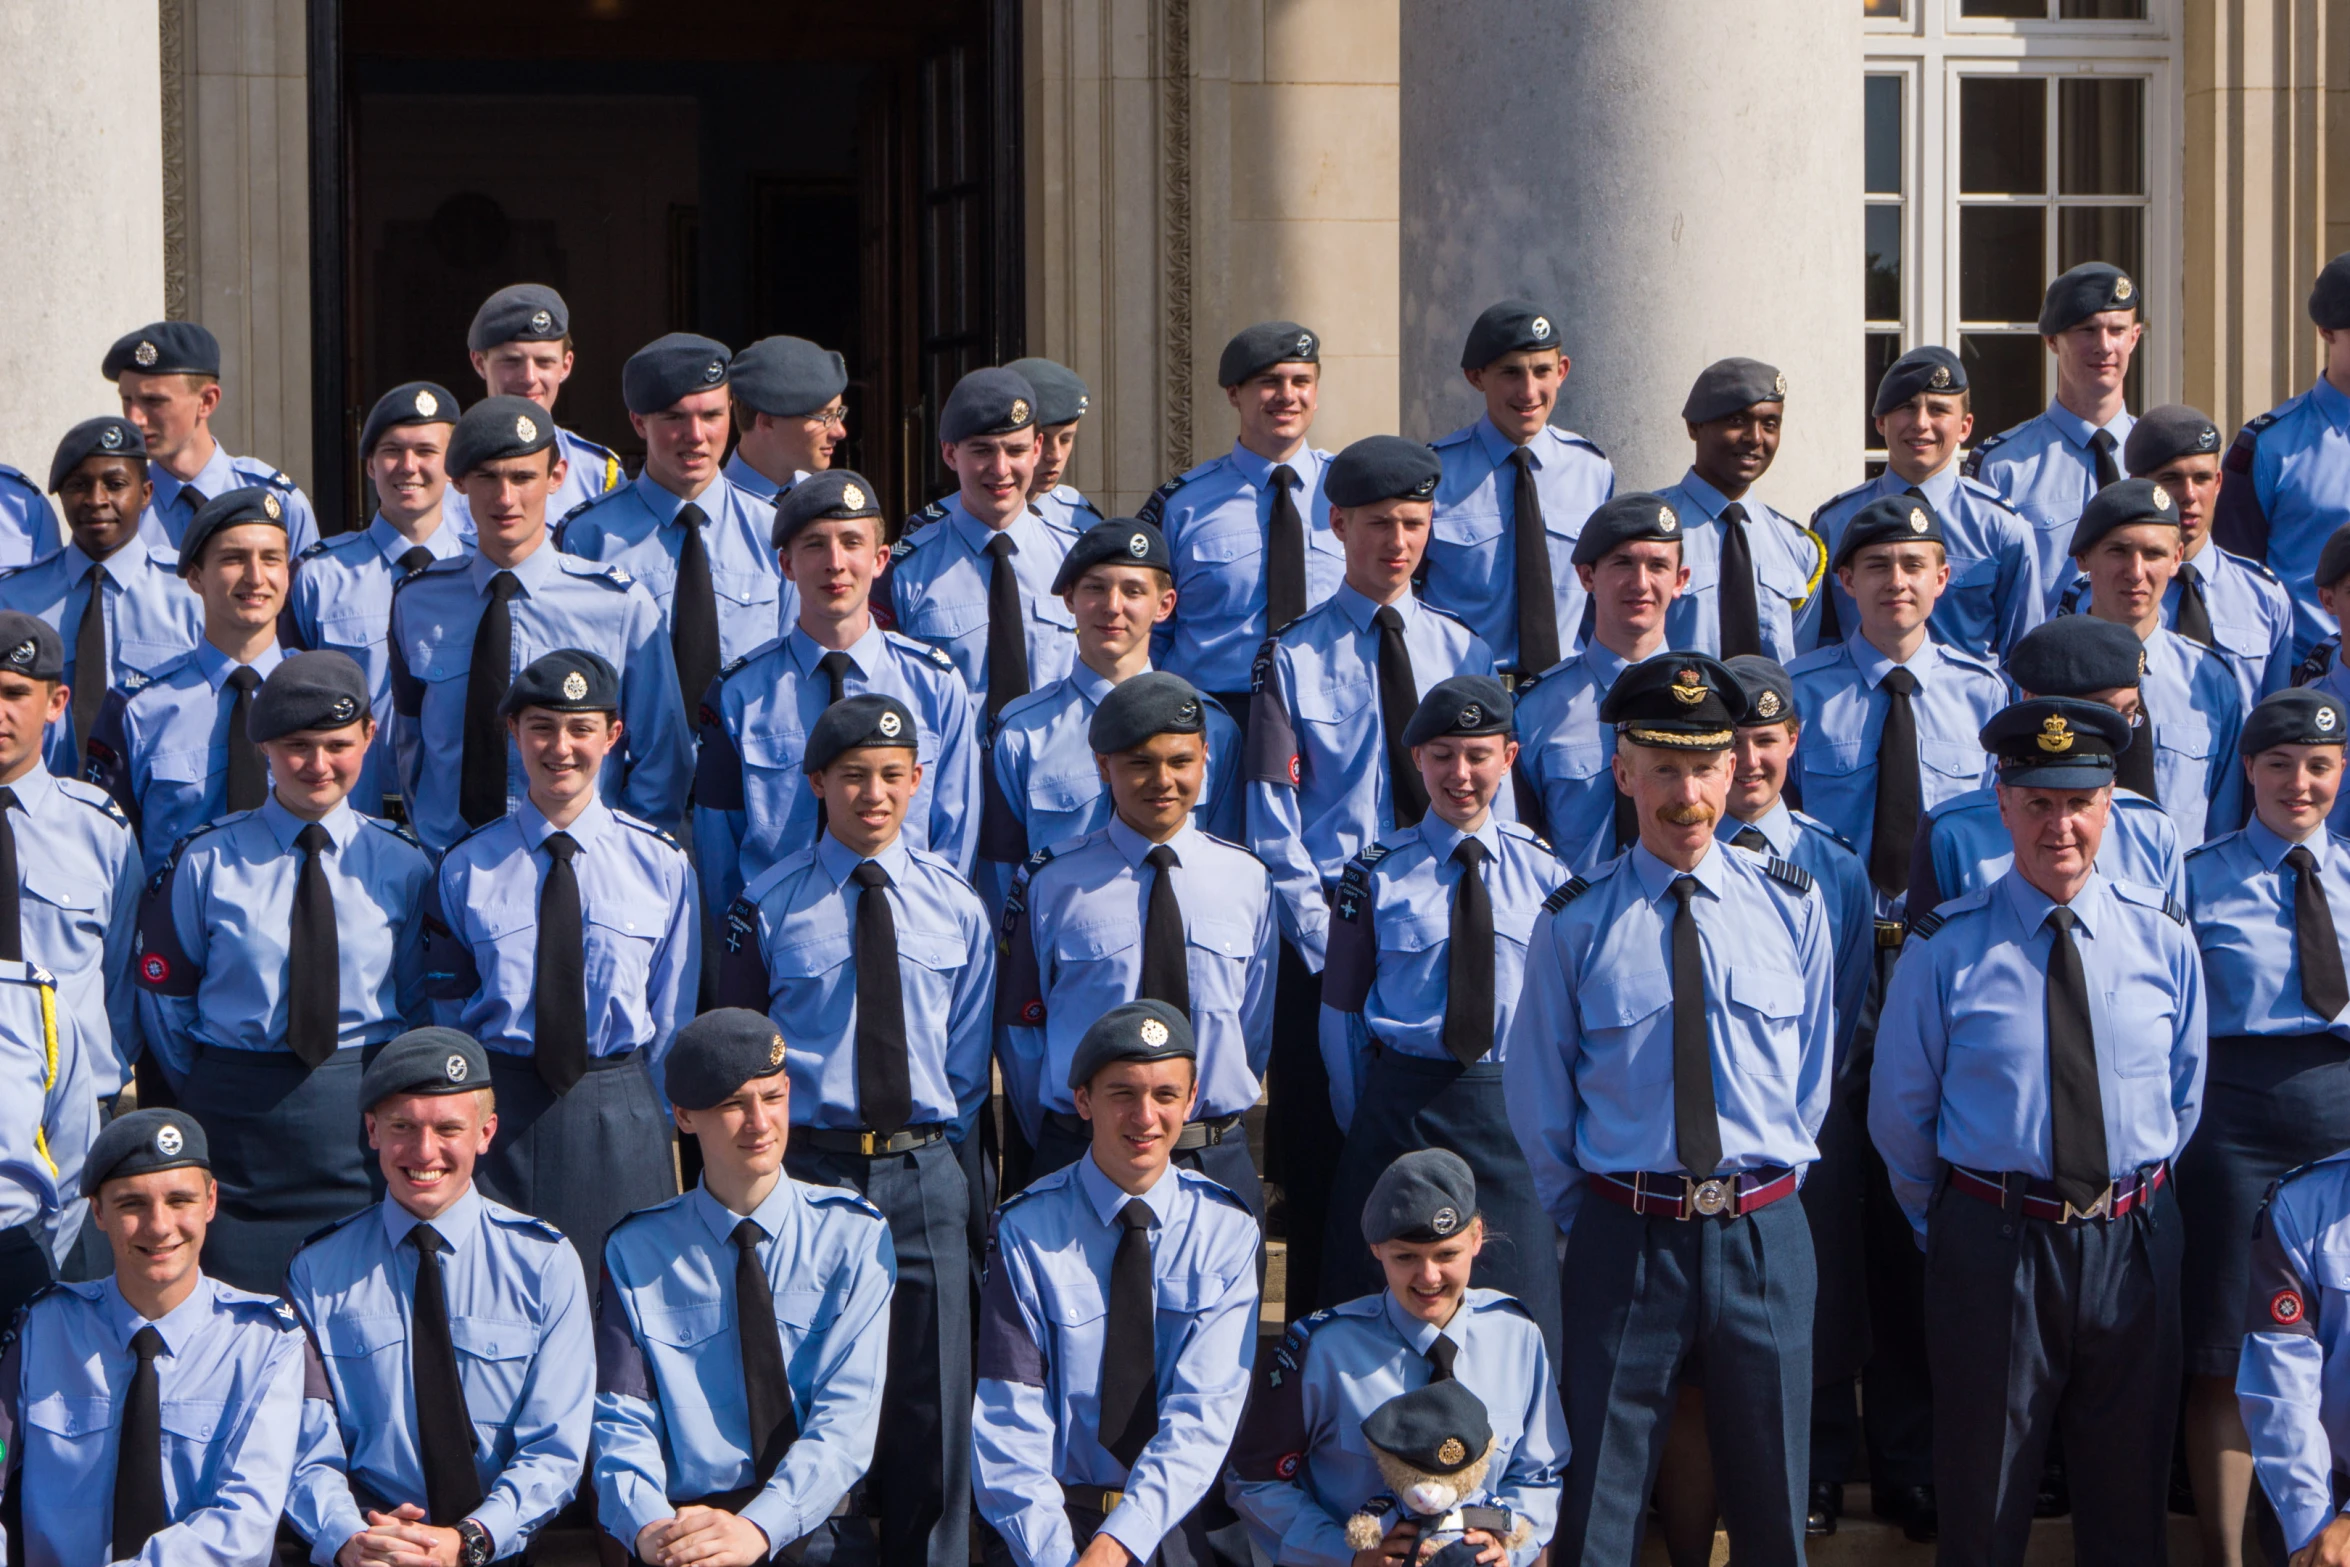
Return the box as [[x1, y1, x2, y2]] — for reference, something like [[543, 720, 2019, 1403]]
[[277, 381, 468, 820]]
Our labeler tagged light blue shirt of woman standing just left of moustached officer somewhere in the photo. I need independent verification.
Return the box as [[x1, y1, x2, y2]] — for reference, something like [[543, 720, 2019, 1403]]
[[1321, 811, 1567, 1130]]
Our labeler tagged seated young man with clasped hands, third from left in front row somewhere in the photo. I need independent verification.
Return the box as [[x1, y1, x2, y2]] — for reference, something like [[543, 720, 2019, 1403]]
[[592, 1008, 898, 1567]]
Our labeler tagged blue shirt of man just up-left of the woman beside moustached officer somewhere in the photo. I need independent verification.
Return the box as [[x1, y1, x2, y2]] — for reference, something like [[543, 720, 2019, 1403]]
[[1246, 585, 1518, 970]]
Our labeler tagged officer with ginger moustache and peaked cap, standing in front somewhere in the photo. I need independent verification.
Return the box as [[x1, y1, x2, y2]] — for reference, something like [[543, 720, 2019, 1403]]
[[1502, 653, 1835, 1565]]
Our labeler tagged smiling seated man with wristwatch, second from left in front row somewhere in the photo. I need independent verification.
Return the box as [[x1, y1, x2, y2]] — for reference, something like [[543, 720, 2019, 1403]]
[[287, 1029, 595, 1567]]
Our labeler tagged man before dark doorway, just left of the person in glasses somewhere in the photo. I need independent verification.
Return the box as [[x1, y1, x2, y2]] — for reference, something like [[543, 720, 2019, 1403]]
[[555, 331, 792, 719]]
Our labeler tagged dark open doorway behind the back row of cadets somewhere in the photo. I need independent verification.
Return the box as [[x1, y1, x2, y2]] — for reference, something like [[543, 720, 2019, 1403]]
[[310, 0, 1025, 529]]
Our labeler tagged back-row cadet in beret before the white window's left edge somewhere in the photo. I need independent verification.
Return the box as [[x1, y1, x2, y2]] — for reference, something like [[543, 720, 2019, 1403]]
[[1798, 345, 2047, 658]]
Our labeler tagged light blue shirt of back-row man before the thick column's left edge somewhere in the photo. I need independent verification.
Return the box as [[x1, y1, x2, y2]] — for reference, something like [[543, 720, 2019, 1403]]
[[1419, 416, 1614, 670]]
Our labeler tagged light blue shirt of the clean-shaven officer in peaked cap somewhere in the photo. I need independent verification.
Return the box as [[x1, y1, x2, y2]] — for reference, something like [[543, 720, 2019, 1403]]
[[1868, 869, 2204, 1238]]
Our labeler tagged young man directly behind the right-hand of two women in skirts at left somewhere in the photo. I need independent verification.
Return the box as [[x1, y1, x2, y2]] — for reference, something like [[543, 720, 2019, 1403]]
[[388, 397, 693, 853]]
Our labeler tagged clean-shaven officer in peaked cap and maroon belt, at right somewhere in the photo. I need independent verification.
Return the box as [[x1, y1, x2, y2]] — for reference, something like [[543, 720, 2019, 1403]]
[[1868, 698, 2204, 1562]]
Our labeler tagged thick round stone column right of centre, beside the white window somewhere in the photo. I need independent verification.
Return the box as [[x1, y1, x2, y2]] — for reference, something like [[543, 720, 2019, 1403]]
[[1403, 0, 1866, 509]]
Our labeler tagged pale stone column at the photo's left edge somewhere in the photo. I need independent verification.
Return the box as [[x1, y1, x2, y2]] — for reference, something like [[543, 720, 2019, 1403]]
[[0, 0, 162, 486]]
